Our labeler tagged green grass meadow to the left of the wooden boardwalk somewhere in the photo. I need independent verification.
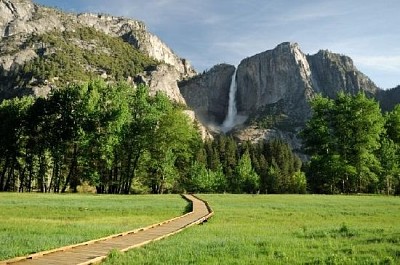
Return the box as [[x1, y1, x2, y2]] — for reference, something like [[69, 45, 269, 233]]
[[0, 193, 188, 260]]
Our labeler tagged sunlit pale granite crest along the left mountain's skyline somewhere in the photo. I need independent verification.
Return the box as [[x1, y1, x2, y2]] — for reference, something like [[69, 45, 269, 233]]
[[0, 0, 195, 77]]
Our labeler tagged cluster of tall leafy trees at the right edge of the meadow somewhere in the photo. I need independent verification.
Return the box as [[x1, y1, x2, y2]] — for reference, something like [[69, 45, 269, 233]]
[[302, 92, 400, 194]]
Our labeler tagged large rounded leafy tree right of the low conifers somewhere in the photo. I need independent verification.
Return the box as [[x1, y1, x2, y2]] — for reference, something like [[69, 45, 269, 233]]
[[302, 93, 384, 192]]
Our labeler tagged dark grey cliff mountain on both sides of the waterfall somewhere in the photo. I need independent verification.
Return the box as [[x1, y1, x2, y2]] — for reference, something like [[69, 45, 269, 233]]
[[180, 42, 400, 149]]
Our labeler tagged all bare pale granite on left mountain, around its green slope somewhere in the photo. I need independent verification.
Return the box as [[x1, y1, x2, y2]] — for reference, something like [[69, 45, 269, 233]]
[[0, 0, 195, 103]]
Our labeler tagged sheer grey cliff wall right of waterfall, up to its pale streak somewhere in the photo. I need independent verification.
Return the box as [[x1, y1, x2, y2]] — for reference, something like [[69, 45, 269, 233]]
[[237, 42, 313, 120]]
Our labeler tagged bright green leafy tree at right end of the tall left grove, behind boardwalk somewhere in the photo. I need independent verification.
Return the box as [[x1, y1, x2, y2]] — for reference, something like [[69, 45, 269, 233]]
[[148, 94, 200, 193]]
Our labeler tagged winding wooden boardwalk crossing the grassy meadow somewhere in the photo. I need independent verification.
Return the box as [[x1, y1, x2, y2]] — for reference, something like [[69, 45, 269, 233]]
[[0, 195, 213, 265]]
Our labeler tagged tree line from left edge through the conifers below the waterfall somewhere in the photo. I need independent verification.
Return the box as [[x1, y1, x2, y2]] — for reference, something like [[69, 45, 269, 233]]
[[0, 80, 306, 194]]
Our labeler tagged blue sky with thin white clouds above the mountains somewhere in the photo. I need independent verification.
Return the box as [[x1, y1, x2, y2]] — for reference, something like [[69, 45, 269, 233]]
[[33, 0, 400, 89]]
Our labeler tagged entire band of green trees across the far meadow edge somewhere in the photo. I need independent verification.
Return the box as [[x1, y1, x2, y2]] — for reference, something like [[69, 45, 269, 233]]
[[0, 80, 400, 194]]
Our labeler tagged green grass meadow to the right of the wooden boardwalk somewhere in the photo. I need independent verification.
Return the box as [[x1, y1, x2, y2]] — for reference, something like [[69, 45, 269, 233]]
[[105, 195, 400, 264]]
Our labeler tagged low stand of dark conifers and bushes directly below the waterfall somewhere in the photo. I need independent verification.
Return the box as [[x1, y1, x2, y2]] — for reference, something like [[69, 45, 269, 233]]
[[186, 135, 307, 193]]
